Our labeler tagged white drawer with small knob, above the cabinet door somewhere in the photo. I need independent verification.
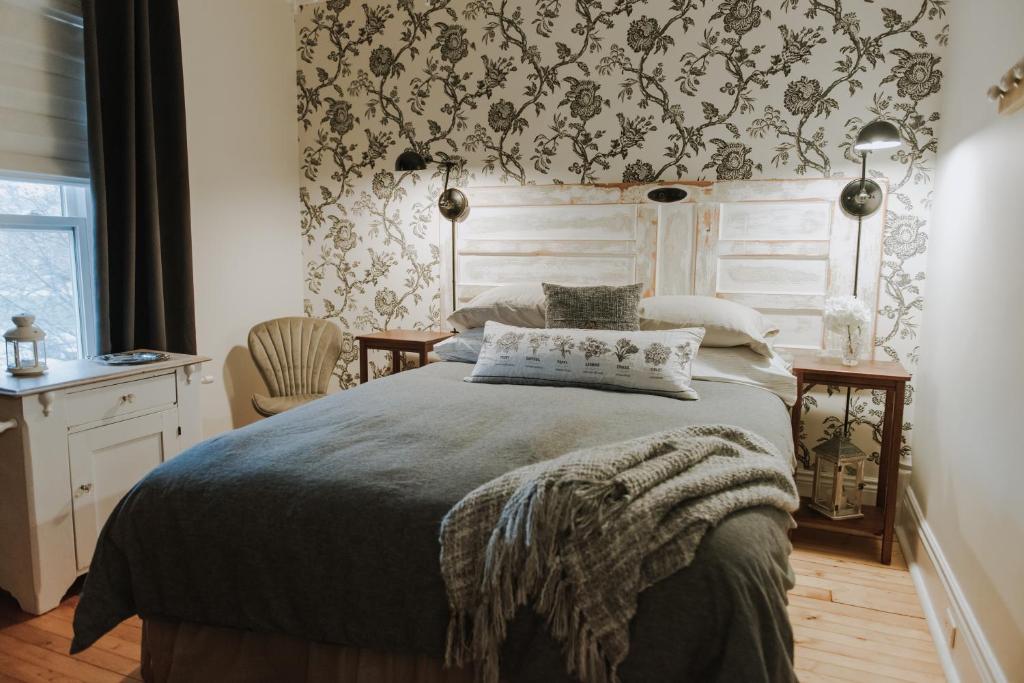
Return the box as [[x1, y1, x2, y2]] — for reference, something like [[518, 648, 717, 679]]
[[65, 375, 177, 427]]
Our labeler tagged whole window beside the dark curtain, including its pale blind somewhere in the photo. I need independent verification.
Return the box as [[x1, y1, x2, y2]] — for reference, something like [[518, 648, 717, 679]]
[[0, 0, 96, 358]]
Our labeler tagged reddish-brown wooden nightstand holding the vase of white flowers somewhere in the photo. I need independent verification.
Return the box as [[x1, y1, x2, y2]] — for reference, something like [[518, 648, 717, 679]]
[[793, 354, 910, 564]]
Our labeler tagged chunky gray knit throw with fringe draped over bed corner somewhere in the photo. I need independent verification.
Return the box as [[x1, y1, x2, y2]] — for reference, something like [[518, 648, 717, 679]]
[[440, 425, 799, 683]]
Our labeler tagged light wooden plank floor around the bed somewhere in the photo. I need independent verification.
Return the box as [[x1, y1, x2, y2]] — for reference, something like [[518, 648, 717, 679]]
[[0, 530, 944, 683]]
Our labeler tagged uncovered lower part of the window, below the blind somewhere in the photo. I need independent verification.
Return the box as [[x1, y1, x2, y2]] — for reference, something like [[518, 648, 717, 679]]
[[0, 175, 95, 359]]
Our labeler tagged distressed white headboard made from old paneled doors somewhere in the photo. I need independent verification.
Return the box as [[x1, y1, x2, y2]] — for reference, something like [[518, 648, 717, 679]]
[[439, 178, 885, 356]]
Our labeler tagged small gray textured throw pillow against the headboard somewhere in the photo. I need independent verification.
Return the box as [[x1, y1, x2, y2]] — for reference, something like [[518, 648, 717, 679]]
[[544, 283, 643, 330]]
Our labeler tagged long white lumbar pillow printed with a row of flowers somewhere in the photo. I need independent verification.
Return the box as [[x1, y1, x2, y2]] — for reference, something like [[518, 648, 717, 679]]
[[466, 322, 703, 399]]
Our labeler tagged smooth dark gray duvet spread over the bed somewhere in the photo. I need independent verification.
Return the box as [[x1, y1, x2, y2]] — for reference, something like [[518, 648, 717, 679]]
[[73, 364, 795, 682]]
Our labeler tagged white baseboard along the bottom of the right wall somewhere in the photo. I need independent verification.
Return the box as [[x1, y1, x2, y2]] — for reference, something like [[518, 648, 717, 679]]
[[896, 486, 1007, 683]]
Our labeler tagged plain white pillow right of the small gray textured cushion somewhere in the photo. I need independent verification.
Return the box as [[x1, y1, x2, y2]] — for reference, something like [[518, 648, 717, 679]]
[[639, 295, 778, 356]]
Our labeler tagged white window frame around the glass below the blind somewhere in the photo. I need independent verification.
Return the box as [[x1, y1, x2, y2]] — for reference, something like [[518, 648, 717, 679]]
[[0, 170, 99, 358]]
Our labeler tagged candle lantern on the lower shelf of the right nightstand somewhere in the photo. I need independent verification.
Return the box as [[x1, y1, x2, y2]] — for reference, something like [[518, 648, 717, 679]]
[[811, 436, 867, 519]]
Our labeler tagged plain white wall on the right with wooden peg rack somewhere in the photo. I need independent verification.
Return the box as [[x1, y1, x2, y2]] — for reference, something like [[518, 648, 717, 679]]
[[910, 0, 1024, 681]]
